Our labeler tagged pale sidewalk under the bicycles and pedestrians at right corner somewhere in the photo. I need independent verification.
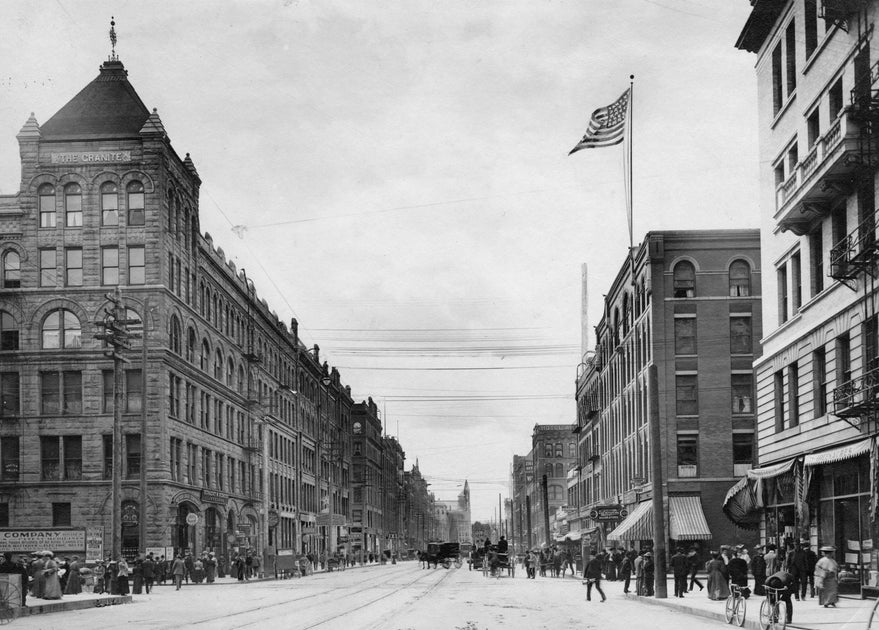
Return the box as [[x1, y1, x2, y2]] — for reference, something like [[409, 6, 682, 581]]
[[626, 577, 879, 630]]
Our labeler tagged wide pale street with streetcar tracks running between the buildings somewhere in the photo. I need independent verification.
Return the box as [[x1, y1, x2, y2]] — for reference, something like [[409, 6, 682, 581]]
[[15, 562, 720, 630]]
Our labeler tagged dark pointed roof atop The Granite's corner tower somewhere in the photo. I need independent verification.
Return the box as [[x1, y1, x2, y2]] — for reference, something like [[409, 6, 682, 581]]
[[40, 60, 150, 140]]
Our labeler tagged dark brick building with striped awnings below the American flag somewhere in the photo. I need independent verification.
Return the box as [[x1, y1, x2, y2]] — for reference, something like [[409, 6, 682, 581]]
[[569, 230, 761, 550]]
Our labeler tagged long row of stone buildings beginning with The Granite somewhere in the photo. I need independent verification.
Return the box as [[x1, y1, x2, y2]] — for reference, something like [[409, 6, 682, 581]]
[[0, 45, 454, 560]]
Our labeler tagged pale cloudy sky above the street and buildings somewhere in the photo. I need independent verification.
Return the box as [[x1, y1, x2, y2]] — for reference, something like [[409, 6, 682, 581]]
[[0, 0, 759, 520]]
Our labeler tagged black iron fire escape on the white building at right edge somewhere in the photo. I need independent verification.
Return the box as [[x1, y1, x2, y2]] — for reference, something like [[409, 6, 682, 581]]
[[825, 0, 879, 435]]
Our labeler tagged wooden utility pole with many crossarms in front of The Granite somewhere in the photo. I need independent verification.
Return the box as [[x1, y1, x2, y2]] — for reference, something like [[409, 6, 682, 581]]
[[95, 287, 138, 560]]
